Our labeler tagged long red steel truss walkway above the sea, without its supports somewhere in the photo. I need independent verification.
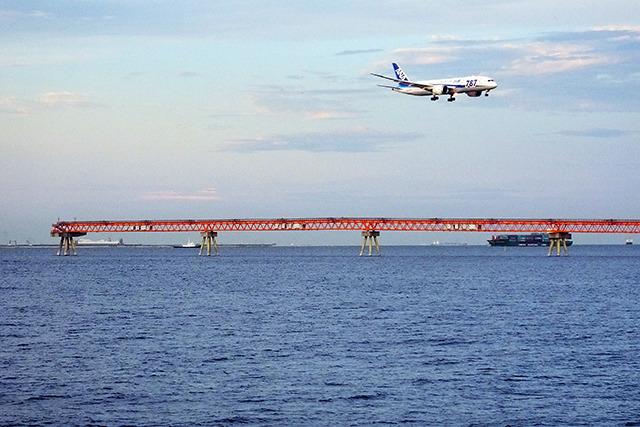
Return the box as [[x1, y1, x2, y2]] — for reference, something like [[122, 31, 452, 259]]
[[51, 217, 640, 236]]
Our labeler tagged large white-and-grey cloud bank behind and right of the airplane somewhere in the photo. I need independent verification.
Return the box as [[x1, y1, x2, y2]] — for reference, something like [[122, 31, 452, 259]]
[[377, 27, 640, 77]]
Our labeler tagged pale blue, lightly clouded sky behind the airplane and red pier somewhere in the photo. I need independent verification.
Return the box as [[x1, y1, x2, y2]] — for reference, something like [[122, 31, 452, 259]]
[[0, 0, 640, 246]]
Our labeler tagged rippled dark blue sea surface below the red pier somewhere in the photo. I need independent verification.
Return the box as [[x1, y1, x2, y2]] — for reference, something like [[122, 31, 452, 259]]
[[0, 245, 640, 426]]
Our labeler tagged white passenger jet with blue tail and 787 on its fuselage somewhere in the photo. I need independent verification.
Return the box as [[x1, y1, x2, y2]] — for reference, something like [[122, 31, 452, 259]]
[[371, 62, 498, 102]]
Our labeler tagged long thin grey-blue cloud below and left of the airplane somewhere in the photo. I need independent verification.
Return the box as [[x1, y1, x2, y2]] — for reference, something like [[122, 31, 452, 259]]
[[222, 131, 422, 153]]
